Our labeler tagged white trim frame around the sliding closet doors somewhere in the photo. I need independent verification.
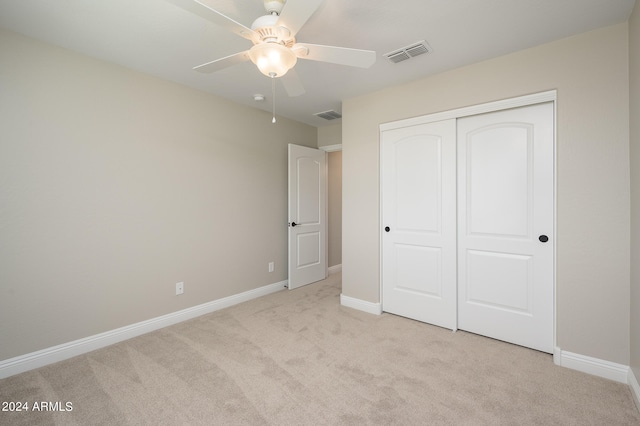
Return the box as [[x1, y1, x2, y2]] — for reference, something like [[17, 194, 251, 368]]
[[378, 90, 558, 346]]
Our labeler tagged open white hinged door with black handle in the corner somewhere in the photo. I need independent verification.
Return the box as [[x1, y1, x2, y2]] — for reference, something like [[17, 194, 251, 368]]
[[289, 144, 327, 289]]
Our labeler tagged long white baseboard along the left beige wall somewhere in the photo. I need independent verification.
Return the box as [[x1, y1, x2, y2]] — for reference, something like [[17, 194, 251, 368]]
[[0, 281, 288, 379]]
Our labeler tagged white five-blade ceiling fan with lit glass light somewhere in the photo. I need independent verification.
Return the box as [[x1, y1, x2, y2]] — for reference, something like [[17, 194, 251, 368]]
[[167, 0, 376, 96]]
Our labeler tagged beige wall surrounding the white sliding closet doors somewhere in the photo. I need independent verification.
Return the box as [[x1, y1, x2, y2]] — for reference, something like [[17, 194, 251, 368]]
[[342, 23, 630, 365]]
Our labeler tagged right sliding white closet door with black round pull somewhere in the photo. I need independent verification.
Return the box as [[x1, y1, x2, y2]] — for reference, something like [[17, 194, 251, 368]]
[[458, 103, 554, 352]]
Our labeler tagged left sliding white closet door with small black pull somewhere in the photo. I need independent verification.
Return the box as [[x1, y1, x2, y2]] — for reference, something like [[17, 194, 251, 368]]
[[381, 120, 457, 329]]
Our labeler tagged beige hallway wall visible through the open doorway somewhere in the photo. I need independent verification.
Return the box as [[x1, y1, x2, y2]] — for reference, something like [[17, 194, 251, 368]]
[[327, 151, 342, 266]]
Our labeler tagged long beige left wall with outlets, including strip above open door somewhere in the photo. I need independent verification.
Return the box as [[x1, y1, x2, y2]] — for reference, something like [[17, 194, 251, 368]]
[[0, 32, 317, 359]]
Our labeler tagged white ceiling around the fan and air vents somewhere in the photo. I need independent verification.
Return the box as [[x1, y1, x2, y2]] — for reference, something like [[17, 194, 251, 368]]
[[0, 0, 635, 126]]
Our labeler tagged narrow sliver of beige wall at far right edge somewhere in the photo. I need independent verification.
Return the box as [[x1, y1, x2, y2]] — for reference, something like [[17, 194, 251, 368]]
[[629, 1, 640, 379]]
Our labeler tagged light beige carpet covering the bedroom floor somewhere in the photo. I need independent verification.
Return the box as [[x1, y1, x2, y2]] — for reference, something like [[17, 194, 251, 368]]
[[0, 274, 640, 426]]
